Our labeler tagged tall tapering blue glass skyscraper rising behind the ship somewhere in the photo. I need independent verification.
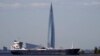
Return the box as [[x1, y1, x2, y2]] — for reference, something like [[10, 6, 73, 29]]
[[48, 3, 55, 48]]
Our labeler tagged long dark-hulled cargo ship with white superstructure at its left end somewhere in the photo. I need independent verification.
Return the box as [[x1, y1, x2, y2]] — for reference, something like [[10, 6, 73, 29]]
[[10, 41, 79, 55]]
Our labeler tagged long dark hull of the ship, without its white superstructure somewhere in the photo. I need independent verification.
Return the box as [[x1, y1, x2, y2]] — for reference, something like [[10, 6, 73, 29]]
[[11, 49, 79, 55]]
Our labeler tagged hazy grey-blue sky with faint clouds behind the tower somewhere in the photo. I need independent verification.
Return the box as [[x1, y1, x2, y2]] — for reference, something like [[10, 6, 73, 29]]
[[0, 0, 100, 49]]
